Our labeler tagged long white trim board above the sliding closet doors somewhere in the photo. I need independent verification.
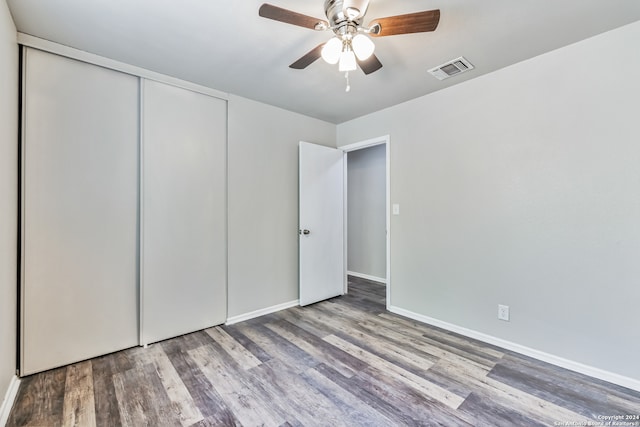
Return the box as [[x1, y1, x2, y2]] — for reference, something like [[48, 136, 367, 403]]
[[17, 33, 229, 100]]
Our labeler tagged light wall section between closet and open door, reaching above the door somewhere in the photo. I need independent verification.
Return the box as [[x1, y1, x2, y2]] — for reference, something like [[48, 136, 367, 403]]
[[228, 96, 336, 317]]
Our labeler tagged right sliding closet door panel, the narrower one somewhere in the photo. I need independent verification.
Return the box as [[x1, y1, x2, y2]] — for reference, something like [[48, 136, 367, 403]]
[[140, 80, 227, 344]]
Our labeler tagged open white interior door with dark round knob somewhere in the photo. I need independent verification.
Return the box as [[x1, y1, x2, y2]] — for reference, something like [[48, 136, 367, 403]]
[[299, 142, 346, 305]]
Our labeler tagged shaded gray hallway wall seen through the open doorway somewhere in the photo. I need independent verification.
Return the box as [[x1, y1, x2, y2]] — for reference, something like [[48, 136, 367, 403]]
[[347, 145, 387, 279]]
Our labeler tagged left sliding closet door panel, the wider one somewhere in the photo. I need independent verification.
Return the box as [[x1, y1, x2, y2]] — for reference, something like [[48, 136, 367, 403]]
[[21, 49, 139, 375]]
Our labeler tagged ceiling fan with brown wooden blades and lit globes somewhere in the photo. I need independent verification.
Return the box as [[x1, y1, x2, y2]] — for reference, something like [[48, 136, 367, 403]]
[[259, 0, 440, 91]]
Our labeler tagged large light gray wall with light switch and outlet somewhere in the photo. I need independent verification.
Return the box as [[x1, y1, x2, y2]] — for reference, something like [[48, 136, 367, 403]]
[[338, 22, 640, 380]]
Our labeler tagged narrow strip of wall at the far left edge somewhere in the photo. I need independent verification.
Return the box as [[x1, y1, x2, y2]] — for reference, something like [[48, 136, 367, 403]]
[[0, 1, 18, 408]]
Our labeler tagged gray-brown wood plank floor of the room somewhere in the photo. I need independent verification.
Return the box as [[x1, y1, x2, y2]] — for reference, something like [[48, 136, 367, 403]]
[[8, 278, 640, 427]]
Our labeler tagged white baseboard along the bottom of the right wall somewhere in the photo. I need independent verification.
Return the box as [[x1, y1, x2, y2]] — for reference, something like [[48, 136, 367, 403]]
[[388, 306, 640, 391]]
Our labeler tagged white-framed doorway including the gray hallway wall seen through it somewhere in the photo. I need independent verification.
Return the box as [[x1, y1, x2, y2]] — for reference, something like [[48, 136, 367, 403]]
[[340, 136, 391, 307]]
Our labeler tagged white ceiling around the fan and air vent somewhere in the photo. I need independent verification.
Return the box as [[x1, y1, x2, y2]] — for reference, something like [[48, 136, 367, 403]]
[[7, 0, 640, 123]]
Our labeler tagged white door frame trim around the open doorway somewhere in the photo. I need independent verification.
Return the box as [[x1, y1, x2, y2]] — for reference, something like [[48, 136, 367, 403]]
[[338, 135, 391, 310]]
